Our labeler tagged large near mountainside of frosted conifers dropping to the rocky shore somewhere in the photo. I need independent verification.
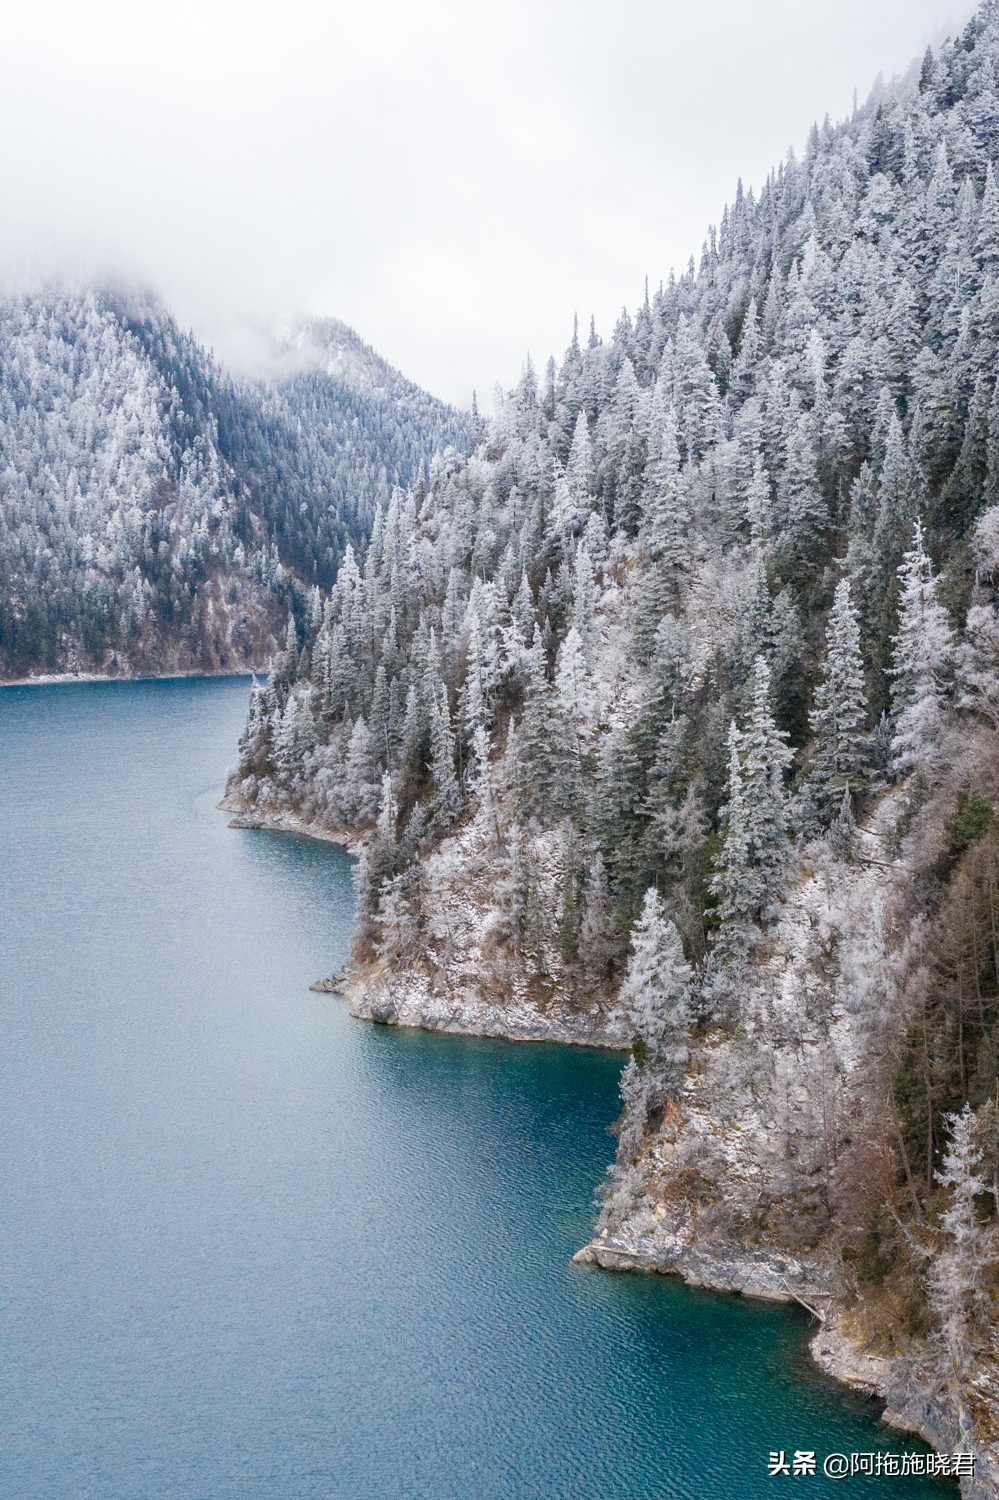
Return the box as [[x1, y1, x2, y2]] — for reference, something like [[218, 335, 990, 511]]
[[231, 0, 999, 1494]]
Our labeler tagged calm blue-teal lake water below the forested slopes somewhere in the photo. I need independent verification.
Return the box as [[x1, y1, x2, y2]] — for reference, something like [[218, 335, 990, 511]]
[[0, 681, 954, 1500]]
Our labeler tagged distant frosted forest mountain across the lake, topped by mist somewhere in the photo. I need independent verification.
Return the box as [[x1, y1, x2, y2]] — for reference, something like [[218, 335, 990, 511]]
[[0, 290, 467, 677]]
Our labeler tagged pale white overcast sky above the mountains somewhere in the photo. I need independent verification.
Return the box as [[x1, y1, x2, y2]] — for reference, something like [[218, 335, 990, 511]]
[[0, 0, 975, 405]]
